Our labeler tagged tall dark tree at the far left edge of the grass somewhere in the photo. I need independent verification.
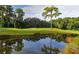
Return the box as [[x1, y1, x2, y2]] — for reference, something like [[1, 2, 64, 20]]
[[0, 5, 13, 27]]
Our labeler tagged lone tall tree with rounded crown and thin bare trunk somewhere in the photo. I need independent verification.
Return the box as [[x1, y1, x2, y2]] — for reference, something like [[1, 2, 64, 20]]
[[42, 6, 61, 28]]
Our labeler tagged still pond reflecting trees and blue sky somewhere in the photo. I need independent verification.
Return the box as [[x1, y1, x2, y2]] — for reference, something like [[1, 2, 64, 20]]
[[0, 34, 77, 54]]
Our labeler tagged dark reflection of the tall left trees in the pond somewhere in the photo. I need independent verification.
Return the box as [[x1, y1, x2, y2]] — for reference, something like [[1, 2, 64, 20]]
[[0, 39, 23, 54]]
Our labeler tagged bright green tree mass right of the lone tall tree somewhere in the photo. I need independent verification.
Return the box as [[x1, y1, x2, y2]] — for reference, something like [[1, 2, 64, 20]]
[[52, 17, 79, 30]]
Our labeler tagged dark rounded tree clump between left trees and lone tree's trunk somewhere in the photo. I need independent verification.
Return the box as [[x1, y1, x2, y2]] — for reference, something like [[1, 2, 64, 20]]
[[24, 17, 50, 28]]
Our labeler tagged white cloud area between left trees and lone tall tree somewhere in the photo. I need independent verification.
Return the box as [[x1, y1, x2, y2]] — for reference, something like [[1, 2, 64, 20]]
[[22, 5, 46, 19]]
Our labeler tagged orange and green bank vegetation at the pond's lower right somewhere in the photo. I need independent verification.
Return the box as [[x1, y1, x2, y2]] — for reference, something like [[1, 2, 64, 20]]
[[63, 37, 79, 54]]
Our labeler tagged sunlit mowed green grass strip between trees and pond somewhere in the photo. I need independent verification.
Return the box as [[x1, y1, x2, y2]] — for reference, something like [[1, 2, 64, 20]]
[[0, 28, 79, 35]]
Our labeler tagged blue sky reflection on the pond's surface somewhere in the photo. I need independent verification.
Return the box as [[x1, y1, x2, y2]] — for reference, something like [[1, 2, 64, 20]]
[[13, 37, 65, 54]]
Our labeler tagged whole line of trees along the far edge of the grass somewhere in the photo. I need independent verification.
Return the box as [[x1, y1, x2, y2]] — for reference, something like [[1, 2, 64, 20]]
[[0, 5, 79, 30]]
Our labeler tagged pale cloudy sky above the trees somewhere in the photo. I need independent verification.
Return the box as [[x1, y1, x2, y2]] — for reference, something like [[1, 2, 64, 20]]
[[13, 5, 79, 19]]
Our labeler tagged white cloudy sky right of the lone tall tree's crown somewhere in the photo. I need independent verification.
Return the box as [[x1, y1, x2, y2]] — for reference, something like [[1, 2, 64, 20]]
[[57, 5, 79, 17]]
